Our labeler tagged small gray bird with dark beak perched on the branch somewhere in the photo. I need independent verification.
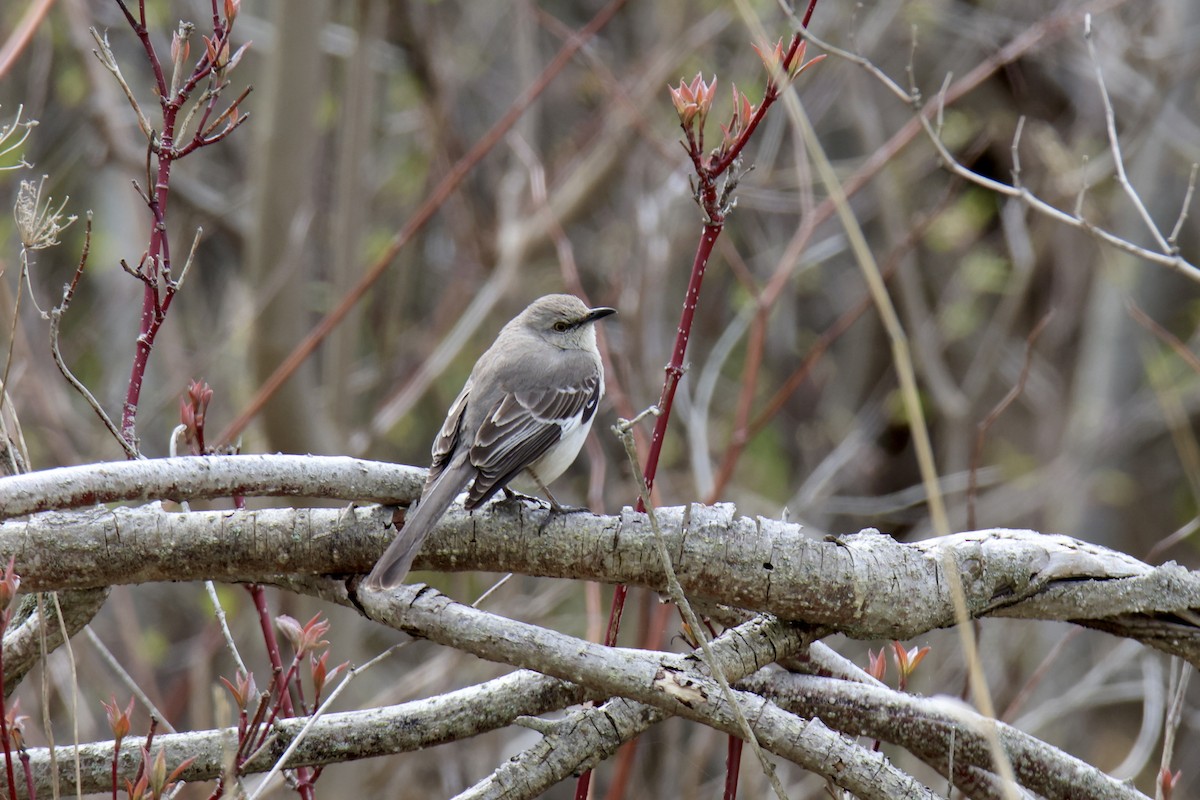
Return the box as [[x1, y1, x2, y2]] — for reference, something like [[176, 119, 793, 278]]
[[365, 294, 616, 590]]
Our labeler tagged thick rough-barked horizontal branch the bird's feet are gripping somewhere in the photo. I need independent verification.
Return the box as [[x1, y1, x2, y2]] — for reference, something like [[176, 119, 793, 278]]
[[0, 482, 1200, 664]]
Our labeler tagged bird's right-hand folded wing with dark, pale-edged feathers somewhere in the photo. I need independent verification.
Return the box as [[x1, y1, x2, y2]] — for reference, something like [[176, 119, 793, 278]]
[[467, 375, 601, 509]]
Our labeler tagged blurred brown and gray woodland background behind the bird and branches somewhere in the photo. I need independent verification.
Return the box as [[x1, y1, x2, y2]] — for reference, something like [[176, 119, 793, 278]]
[[0, 0, 1200, 798]]
